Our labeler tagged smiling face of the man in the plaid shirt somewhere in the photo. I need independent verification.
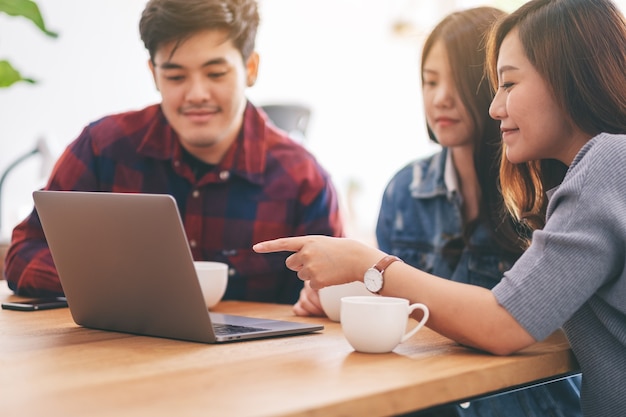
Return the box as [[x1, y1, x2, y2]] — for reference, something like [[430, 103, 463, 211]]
[[149, 30, 258, 163]]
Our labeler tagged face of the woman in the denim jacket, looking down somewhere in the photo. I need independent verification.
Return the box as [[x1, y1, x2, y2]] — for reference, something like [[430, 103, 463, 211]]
[[422, 40, 475, 147]]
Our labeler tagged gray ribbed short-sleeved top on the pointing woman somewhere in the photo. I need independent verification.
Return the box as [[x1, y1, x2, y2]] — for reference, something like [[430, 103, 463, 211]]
[[493, 133, 626, 417]]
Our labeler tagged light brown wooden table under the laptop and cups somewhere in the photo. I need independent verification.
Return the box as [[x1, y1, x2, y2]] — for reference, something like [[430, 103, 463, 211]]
[[0, 282, 578, 417]]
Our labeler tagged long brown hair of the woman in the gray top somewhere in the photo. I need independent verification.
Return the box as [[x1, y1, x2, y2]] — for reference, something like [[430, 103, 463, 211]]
[[487, 0, 626, 229]]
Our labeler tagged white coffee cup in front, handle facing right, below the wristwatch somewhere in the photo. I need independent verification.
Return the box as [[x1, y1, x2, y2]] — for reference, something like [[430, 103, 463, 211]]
[[341, 296, 429, 353]]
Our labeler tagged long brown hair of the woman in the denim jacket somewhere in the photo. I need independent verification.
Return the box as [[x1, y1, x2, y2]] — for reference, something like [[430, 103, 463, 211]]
[[421, 7, 525, 254]]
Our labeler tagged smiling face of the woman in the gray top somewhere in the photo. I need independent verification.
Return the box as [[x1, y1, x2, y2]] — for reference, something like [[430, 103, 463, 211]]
[[489, 30, 590, 165]]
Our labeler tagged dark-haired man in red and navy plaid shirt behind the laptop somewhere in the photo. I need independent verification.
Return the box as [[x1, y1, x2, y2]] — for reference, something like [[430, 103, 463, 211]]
[[5, 0, 343, 304]]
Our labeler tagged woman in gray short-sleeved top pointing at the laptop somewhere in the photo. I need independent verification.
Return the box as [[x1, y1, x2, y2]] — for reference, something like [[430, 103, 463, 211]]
[[255, 0, 626, 417]]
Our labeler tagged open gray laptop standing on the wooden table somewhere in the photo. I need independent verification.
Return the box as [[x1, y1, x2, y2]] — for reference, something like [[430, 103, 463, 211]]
[[33, 191, 324, 343]]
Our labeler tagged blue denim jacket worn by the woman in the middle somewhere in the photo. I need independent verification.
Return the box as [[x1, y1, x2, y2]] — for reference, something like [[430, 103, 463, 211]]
[[376, 149, 517, 289]]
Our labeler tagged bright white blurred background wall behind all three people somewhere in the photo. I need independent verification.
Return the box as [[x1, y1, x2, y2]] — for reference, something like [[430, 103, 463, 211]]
[[0, 0, 626, 239]]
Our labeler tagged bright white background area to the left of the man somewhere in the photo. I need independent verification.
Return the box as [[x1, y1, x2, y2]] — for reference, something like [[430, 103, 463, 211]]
[[0, 0, 158, 236]]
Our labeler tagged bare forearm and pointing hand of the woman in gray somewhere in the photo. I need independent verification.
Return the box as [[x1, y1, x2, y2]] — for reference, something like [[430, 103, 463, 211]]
[[254, 236, 535, 355]]
